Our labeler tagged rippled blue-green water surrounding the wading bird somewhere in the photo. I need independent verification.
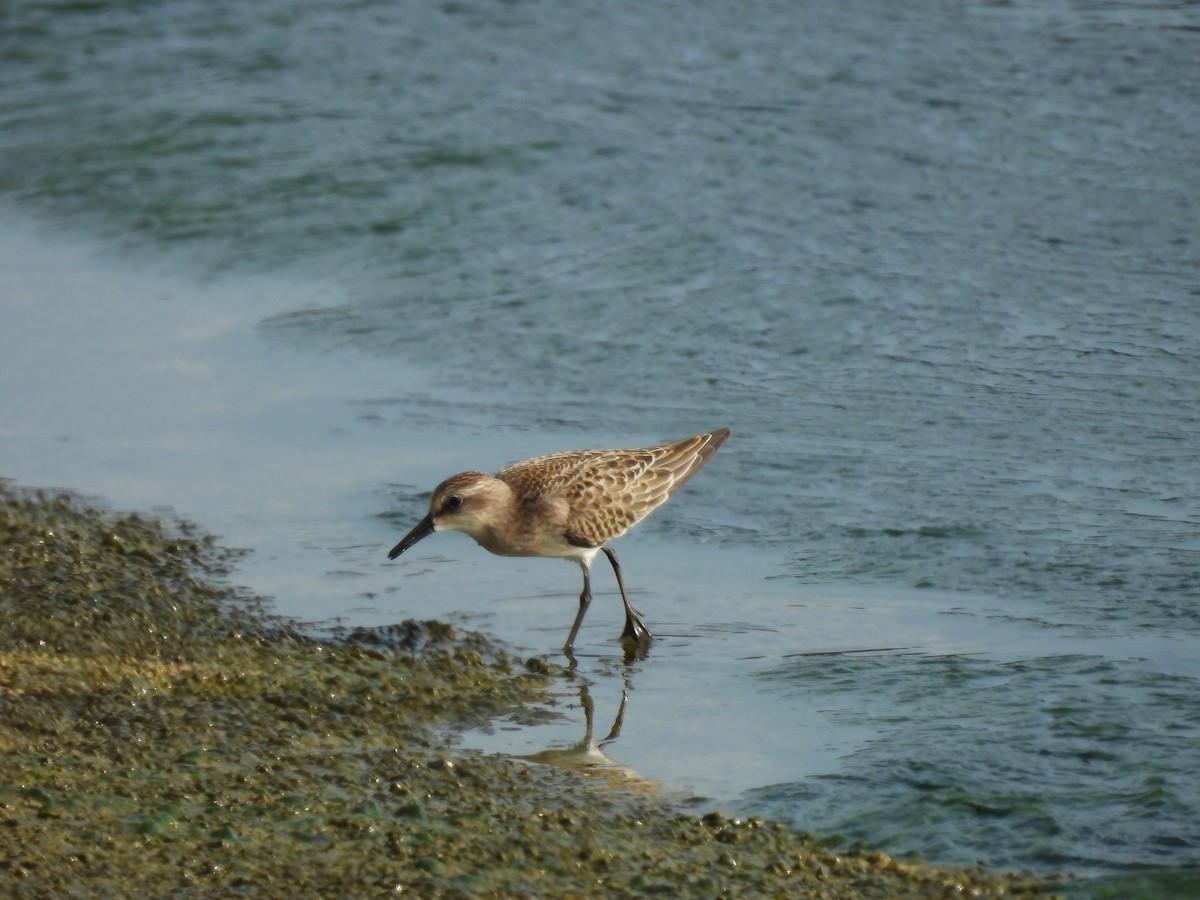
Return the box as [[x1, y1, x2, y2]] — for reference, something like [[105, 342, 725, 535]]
[[0, 0, 1200, 896]]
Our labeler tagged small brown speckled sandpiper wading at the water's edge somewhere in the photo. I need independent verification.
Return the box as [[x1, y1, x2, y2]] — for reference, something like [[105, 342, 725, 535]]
[[388, 428, 730, 655]]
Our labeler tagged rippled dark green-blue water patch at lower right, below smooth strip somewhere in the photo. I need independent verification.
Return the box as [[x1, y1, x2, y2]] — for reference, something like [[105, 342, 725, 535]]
[[748, 655, 1200, 870]]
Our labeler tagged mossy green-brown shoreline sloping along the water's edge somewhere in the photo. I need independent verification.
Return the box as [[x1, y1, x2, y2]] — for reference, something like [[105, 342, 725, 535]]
[[0, 482, 1052, 898]]
